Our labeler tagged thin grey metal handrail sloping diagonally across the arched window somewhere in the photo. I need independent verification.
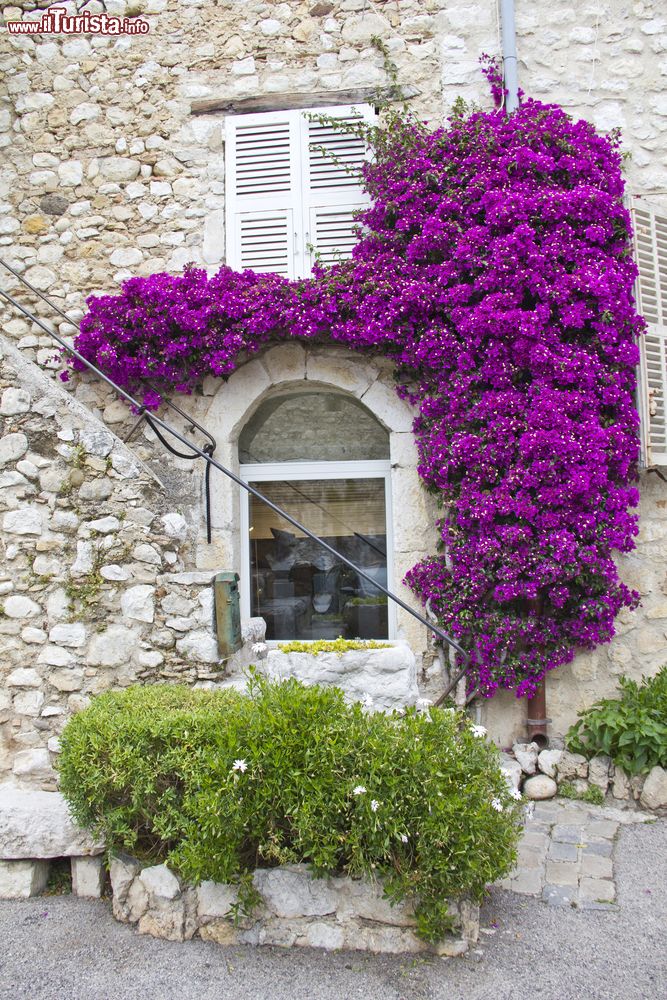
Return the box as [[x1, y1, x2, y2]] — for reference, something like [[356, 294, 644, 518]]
[[0, 257, 470, 704]]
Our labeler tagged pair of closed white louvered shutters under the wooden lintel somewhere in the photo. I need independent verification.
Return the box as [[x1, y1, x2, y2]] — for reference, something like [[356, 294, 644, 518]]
[[225, 105, 375, 278]]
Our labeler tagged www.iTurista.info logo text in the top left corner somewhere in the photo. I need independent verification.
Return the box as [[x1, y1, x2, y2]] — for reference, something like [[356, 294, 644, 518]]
[[0, 0, 150, 35]]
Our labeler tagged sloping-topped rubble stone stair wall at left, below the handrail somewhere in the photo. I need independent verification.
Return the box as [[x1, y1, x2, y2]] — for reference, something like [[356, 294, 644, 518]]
[[0, 343, 247, 789]]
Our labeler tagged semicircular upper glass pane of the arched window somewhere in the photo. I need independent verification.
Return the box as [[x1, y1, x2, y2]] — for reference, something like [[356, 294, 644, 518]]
[[239, 392, 389, 464]]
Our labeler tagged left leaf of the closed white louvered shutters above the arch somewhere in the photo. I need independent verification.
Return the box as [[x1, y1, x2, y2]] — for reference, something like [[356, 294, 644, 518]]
[[225, 112, 303, 278]]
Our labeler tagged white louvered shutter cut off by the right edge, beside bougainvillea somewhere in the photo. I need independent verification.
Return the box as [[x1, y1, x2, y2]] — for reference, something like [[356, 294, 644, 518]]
[[632, 198, 667, 467]]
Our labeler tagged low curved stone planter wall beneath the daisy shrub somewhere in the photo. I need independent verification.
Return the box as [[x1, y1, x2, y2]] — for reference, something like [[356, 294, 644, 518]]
[[111, 855, 479, 956]]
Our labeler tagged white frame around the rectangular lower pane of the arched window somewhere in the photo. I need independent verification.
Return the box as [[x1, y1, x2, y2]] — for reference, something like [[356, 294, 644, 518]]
[[239, 459, 396, 645]]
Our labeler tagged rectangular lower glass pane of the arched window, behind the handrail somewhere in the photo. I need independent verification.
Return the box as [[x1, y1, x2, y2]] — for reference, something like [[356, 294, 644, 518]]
[[249, 479, 388, 639]]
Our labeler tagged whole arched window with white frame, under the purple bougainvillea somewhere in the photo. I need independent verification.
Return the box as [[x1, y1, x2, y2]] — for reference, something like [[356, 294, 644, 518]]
[[239, 389, 394, 639]]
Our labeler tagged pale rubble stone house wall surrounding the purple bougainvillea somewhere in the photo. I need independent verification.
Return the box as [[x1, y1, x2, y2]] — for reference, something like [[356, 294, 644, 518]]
[[0, 0, 667, 752]]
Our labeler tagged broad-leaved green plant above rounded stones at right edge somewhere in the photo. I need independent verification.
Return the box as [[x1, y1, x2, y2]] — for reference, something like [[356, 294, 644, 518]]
[[565, 666, 667, 774]]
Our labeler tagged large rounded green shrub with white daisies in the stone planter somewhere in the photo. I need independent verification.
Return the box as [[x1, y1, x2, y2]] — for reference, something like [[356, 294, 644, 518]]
[[59, 677, 520, 940]]
